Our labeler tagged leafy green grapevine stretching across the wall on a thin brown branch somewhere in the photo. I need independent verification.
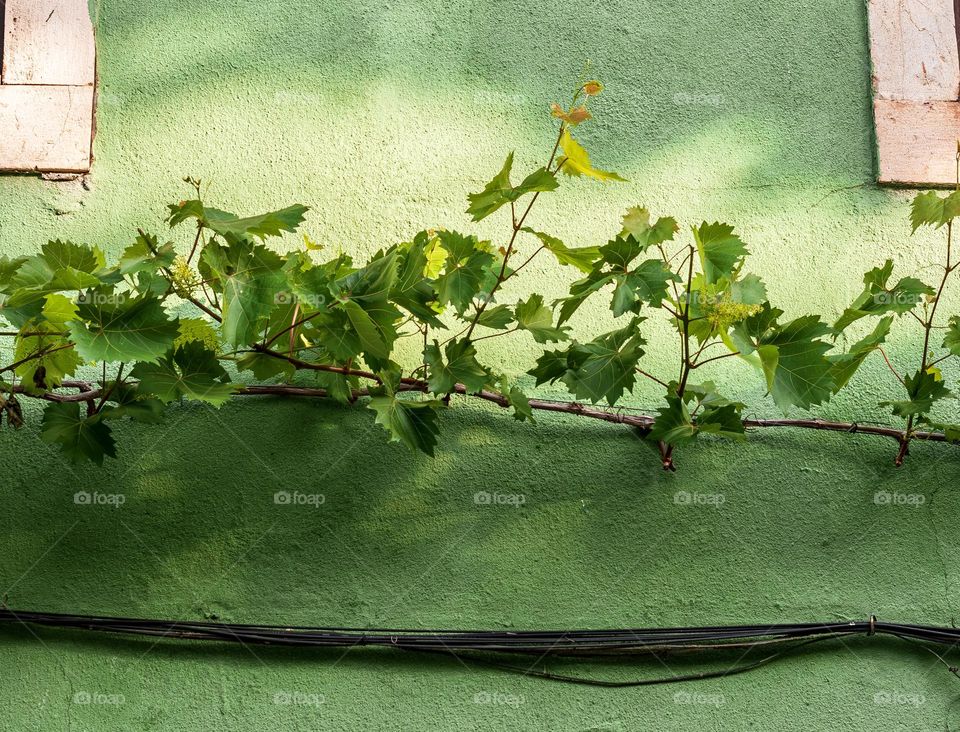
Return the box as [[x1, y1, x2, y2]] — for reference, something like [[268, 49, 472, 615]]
[[0, 82, 960, 466]]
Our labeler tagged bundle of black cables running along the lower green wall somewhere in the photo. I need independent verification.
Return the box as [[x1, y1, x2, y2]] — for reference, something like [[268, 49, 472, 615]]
[[0, 608, 960, 687]]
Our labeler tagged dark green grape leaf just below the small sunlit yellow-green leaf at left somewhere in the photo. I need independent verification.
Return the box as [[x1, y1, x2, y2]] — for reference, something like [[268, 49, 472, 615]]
[[130, 341, 237, 407]]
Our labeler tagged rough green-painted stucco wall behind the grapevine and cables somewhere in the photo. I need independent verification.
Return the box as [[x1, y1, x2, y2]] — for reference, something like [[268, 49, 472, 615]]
[[0, 0, 960, 732]]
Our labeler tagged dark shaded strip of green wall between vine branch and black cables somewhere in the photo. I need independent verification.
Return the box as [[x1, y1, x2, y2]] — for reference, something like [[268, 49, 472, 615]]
[[0, 400, 960, 628]]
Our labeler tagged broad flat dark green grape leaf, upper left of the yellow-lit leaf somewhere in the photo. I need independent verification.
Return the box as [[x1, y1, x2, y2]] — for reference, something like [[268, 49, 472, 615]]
[[67, 289, 180, 362]]
